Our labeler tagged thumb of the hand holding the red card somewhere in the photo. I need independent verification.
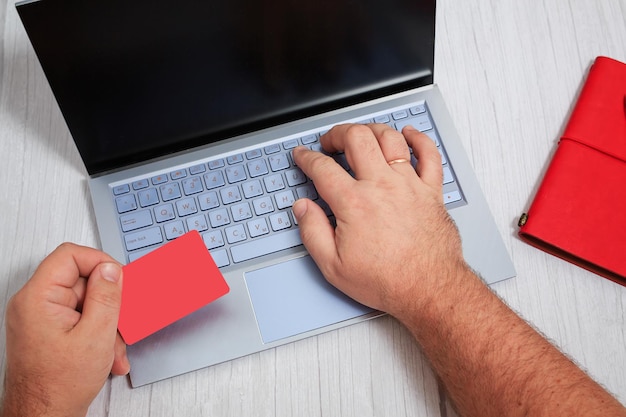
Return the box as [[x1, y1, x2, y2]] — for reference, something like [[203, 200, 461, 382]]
[[77, 262, 122, 345]]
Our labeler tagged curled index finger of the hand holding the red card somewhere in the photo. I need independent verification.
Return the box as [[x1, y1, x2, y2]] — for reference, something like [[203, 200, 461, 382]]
[[31, 243, 115, 288]]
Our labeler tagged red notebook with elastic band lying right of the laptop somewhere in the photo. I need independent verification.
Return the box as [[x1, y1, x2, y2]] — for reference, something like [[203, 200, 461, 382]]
[[519, 57, 626, 286]]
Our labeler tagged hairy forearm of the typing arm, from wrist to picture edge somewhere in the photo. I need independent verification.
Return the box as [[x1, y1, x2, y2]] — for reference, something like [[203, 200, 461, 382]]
[[398, 269, 626, 417]]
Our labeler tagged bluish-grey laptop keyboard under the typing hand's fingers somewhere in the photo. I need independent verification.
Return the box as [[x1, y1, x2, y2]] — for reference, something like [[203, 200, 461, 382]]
[[112, 104, 463, 267]]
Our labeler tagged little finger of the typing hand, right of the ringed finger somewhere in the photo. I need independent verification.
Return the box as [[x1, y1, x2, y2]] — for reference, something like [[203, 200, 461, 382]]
[[402, 126, 443, 189]]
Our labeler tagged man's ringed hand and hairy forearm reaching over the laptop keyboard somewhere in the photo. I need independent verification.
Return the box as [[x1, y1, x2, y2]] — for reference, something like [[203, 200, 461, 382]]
[[293, 125, 626, 417]]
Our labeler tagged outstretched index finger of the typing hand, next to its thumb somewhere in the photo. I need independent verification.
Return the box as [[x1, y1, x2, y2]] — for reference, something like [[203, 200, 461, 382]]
[[293, 146, 354, 208]]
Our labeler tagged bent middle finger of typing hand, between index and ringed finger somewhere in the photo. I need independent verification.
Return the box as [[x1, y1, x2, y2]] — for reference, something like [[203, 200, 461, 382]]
[[320, 124, 387, 179]]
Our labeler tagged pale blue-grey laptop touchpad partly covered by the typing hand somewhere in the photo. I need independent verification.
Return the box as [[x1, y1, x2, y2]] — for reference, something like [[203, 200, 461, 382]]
[[245, 256, 374, 343]]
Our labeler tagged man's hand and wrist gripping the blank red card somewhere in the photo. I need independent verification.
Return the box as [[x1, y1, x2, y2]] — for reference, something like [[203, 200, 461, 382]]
[[2, 243, 130, 417]]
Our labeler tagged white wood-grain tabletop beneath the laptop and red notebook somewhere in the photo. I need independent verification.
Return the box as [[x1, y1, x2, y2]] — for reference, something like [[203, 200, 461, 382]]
[[0, 0, 626, 417]]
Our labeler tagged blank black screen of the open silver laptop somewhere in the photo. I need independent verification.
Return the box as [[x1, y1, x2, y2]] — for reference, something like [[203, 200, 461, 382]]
[[17, 0, 435, 174]]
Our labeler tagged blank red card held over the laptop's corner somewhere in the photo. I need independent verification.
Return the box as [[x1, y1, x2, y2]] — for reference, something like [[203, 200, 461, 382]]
[[118, 231, 229, 345]]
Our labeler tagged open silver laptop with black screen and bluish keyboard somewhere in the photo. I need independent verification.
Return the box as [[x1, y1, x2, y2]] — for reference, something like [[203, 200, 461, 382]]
[[16, 0, 515, 387]]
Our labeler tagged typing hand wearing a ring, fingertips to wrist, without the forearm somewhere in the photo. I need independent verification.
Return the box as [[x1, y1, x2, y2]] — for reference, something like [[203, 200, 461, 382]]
[[293, 125, 466, 315]]
